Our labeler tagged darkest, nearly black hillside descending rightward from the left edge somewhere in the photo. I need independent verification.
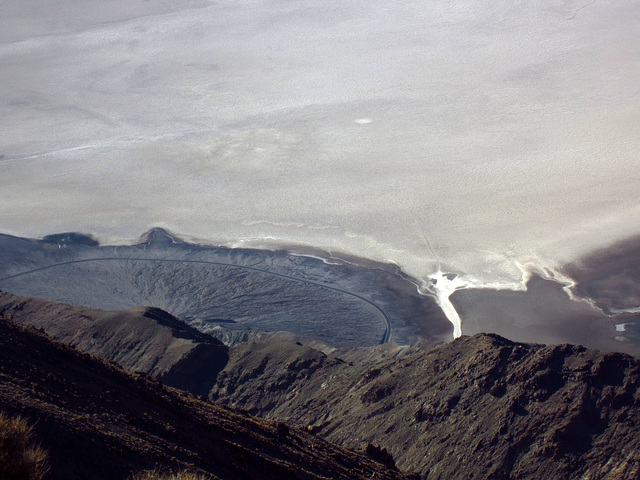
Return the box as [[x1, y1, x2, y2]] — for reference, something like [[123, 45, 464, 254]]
[[0, 317, 416, 480]]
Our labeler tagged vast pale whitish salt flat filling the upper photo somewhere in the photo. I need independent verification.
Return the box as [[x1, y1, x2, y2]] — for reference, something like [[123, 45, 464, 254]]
[[0, 0, 640, 288]]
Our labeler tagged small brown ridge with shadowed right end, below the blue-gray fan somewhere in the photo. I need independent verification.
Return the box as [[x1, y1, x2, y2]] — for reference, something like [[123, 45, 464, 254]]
[[0, 291, 229, 395]]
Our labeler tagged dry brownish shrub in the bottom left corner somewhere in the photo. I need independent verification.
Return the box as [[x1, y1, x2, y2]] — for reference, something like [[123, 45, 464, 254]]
[[0, 412, 49, 480]]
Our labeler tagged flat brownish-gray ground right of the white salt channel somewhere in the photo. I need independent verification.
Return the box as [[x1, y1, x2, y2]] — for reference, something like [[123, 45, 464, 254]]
[[449, 236, 640, 356]]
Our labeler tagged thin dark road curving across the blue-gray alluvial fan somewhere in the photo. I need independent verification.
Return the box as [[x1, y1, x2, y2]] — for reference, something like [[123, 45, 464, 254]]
[[0, 257, 391, 344]]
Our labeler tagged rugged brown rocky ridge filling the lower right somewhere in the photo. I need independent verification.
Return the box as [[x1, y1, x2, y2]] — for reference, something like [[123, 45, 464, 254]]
[[211, 334, 640, 480]]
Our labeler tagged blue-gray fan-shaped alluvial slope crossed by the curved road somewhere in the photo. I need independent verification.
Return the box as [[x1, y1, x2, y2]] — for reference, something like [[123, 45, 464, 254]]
[[0, 229, 452, 347]]
